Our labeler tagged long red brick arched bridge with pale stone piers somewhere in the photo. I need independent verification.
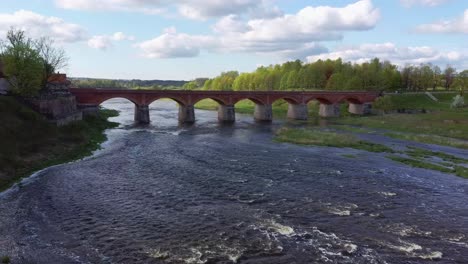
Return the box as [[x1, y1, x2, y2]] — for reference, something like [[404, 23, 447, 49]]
[[70, 88, 379, 123]]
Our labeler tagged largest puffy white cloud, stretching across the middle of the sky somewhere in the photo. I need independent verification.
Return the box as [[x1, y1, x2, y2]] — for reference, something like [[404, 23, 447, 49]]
[[137, 0, 380, 58]]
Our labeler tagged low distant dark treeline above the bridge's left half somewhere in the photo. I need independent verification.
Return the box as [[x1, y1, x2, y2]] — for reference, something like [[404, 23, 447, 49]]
[[69, 78, 187, 89]]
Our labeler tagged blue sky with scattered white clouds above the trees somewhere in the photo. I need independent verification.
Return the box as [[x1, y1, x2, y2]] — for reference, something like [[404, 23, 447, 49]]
[[0, 0, 468, 80]]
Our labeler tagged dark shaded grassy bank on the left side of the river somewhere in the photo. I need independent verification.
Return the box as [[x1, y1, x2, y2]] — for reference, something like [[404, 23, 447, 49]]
[[0, 97, 118, 191]]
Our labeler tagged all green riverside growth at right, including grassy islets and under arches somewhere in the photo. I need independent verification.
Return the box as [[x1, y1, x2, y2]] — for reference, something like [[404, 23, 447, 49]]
[[196, 93, 468, 178]]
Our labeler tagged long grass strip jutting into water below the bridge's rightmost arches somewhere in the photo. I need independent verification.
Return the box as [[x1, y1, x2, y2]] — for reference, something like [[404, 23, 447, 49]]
[[274, 128, 393, 153]]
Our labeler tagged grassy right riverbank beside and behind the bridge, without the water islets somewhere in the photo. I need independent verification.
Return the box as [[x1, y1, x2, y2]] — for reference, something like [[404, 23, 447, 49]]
[[195, 93, 468, 149]]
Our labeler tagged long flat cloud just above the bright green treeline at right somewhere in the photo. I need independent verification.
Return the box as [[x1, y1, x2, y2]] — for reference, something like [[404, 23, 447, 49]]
[[307, 42, 467, 66]]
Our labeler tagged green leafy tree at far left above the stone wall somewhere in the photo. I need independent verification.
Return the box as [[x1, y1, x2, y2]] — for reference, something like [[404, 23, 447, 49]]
[[1, 29, 45, 96]]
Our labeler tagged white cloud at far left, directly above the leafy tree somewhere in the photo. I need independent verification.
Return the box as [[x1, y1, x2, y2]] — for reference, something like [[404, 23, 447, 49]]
[[0, 10, 86, 43]]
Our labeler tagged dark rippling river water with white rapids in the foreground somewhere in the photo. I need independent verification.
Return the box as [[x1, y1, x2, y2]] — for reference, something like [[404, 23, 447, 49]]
[[0, 100, 468, 263]]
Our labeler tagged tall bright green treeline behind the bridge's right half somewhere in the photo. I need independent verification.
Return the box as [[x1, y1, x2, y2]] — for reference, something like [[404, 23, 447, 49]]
[[184, 58, 468, 91]]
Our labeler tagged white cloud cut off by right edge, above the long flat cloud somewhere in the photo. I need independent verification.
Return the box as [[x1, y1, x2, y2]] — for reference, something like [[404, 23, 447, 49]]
[[415, 9, 468, 34]]
